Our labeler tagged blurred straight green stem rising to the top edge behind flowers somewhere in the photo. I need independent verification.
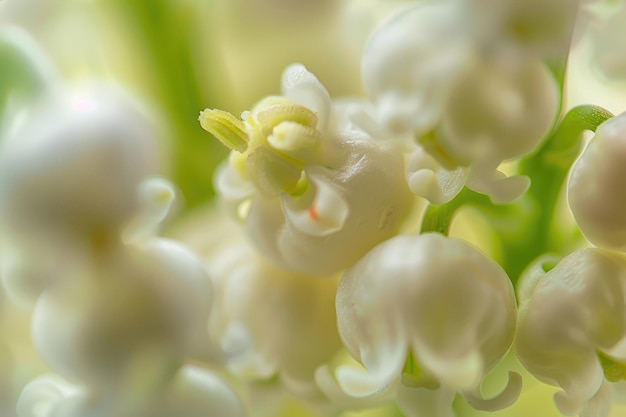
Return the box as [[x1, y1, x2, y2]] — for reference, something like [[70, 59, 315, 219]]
[[111, 0, 227, 208]]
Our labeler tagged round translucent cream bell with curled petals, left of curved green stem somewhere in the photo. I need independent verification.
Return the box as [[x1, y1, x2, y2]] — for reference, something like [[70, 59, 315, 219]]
[[436, 53, 559, 202]]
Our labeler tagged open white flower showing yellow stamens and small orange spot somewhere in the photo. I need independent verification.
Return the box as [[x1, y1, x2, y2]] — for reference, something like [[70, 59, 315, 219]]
[[200, 65, 412, 275]]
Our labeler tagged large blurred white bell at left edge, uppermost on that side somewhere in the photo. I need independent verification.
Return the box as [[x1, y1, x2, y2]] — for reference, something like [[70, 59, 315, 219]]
[[0, 84, 159, 242]]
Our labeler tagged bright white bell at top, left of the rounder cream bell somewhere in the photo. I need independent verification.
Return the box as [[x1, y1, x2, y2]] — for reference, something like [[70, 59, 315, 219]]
[[361, 1, 474, 136]]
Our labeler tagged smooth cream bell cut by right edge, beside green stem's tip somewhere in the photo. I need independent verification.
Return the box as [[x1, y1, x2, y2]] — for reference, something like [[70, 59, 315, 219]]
[[567, 113, 626, 251]]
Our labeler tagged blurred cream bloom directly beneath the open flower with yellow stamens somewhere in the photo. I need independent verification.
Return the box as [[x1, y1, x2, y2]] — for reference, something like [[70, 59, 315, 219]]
[[176, 206, 341, 399]]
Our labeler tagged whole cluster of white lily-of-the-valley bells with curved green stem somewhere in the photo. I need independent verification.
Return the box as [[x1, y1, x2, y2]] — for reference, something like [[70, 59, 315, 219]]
[[0, 0, 626, 417]]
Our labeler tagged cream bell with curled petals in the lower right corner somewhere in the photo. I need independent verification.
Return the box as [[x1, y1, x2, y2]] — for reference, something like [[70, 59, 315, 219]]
[[515, 248, 626, 417]]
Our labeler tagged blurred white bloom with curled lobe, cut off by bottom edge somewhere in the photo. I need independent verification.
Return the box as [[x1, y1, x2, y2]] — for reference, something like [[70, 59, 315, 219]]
[[17, 365, 246, 417]]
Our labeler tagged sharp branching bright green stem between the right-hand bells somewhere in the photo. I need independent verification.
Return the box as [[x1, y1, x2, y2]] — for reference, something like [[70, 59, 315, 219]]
[[420, 105, 613, 284]]
